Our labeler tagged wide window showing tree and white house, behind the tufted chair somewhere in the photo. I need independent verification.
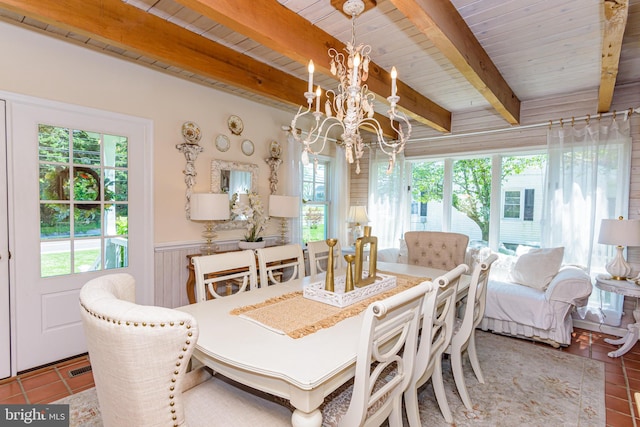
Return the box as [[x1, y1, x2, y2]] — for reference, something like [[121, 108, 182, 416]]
[[410, 153, 546, 254]]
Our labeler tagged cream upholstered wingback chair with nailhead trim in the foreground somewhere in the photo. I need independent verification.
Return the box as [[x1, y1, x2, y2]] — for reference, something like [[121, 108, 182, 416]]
[[80, 273, 292, 427]]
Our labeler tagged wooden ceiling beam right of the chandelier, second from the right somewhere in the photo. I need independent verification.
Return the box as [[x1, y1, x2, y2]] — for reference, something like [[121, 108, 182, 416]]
[[390, 0, 520, 124]]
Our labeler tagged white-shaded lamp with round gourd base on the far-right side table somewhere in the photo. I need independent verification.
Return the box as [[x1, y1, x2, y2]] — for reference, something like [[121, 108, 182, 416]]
[[598, 217, 640, 280]]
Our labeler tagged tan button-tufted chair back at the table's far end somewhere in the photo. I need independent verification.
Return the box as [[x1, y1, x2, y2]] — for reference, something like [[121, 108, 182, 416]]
[[404, 231, 469, 271]]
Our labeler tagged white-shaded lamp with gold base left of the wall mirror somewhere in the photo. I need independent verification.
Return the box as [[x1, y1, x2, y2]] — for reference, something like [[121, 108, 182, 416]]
[[191, 193, 229, 255]]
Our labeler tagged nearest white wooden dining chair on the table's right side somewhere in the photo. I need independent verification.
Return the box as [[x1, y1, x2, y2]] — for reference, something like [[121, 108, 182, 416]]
[[322, 281, 437, 427]]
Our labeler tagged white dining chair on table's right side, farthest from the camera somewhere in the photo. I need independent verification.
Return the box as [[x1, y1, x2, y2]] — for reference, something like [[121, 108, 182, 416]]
[[445, 254, 498, 411]]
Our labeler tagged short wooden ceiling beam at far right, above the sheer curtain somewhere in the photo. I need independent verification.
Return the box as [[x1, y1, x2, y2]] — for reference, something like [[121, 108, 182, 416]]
[[598, 0, 629, 113]]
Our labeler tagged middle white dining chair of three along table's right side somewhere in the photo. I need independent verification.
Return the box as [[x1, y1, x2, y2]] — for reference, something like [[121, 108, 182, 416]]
[[404, 264, 469, 427]]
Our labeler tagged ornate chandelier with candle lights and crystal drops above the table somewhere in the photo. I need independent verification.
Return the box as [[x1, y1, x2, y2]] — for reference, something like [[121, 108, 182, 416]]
[[291, 0, 411, 174]]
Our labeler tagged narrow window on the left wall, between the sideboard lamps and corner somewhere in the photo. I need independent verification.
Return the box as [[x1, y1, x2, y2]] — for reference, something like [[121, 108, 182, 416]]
[[302, 159, 330, 243]]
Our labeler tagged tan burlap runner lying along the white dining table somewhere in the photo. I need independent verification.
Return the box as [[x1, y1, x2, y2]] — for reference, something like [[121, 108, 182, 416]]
[[230, 271, 431, 339]]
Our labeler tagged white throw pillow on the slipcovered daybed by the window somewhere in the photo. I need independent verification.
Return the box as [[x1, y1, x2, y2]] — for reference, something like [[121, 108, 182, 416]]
[[511, 247, 564, 291]]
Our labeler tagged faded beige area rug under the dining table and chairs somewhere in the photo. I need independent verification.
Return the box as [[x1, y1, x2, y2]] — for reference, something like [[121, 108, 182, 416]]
[[54, 330, 606, 427]]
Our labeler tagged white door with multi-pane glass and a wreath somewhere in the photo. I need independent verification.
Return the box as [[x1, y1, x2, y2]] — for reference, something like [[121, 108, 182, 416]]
[[8, 98, 153, 371]]
